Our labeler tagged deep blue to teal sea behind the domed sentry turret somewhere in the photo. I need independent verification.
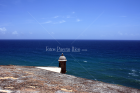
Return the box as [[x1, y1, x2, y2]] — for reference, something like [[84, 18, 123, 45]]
[[0, 40, 140, 89]]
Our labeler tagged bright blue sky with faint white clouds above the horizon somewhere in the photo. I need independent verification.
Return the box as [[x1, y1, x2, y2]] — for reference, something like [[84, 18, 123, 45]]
[[0, 0, 140, 40]]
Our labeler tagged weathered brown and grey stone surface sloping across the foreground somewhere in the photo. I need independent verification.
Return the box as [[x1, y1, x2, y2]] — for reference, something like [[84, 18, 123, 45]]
[[0, 66, 140, 93]]
